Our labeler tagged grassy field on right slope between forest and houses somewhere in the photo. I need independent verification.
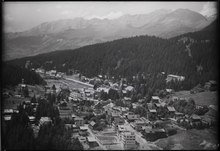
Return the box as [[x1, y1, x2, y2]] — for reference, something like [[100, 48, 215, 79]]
[[172, 91, 218, 106]]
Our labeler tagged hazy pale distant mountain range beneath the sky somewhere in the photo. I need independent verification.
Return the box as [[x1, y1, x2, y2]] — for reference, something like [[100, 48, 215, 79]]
[[3, 9, 213, 60]]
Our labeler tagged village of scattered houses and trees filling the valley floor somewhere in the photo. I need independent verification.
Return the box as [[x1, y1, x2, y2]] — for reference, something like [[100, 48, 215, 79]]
[[3, 63, 217, 150]]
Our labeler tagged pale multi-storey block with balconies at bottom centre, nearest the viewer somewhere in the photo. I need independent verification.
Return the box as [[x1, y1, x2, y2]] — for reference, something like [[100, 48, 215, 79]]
[[122, 132, 136, 150]]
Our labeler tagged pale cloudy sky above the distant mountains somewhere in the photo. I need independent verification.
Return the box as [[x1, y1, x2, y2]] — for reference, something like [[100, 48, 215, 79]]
[[3, 1, 217, 32]]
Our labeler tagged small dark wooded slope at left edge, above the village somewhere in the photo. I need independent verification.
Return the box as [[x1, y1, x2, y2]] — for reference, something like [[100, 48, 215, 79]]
[[2, 64, 45, 87]]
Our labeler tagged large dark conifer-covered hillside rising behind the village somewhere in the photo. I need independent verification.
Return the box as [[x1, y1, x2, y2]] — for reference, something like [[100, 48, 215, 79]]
[[7, 20, 218, 89]]
